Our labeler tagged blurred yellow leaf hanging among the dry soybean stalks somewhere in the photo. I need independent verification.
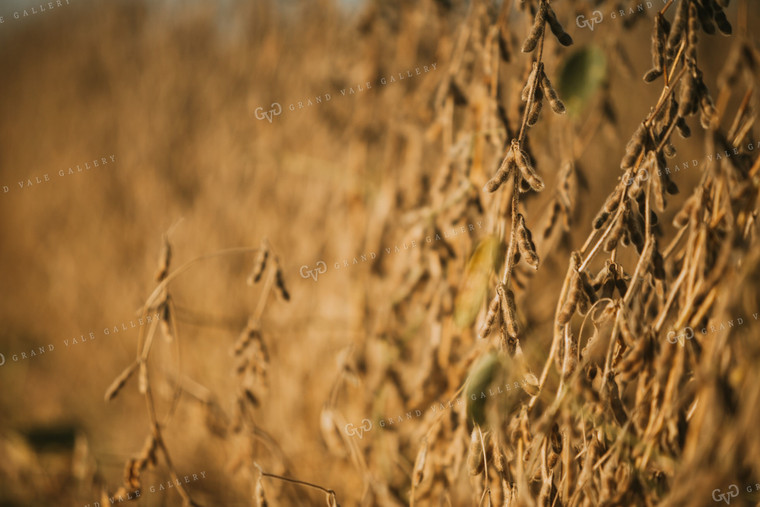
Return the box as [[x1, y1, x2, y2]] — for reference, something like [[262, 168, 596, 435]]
[[454, 235, 506, 328]]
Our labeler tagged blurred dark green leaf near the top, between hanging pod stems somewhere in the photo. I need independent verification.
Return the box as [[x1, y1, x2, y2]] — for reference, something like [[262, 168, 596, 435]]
[[557, 45, 607, 118]]
